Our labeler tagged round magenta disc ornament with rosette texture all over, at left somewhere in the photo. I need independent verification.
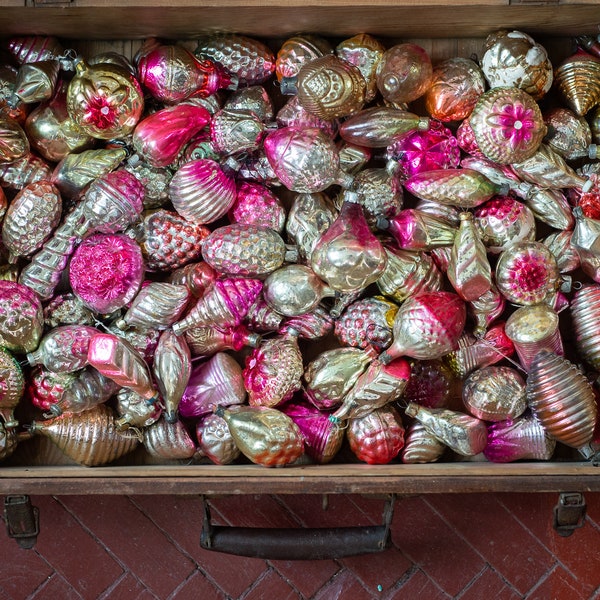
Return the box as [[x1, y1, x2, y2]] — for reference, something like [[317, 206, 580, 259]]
[[69, 234, 144, 314]]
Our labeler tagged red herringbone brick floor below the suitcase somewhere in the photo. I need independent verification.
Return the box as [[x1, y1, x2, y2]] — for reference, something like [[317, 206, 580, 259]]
[[0, 494, 600, 600]]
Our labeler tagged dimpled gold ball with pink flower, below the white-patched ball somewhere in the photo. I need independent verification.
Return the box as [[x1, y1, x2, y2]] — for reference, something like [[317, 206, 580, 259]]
[[469, 87, 547, 164]]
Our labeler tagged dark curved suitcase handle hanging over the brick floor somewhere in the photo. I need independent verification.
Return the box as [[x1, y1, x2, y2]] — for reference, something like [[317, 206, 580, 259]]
[[200, 495, 395, 560]]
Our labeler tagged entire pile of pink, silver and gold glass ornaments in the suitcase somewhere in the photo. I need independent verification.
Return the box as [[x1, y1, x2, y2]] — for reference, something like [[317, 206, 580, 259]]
[[0, 31, 600, 466]]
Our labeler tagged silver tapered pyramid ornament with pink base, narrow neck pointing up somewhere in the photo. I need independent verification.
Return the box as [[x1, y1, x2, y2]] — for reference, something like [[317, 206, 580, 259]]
[[446, 212, 492, 302]]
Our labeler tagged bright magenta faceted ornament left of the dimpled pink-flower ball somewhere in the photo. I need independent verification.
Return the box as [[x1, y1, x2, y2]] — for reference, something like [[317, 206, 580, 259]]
[[386, 120, 460, 178]]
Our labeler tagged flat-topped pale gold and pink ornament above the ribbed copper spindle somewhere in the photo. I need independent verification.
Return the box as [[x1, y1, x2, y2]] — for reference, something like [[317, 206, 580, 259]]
[[506, 304, 564, 371]]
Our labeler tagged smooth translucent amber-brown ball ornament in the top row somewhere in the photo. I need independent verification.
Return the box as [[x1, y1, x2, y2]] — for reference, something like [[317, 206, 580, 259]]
[[377, 43, 433, 104]]
